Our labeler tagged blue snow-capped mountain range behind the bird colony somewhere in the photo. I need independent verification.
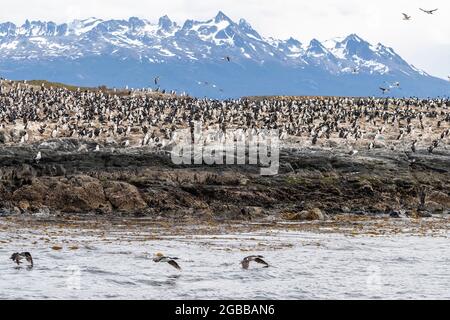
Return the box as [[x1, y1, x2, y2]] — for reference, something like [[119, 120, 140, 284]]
[[0, 12, 450, 97]]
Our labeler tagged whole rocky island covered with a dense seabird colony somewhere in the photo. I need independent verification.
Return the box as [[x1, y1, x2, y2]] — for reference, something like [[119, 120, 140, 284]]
[[0, 80, 450, 220]]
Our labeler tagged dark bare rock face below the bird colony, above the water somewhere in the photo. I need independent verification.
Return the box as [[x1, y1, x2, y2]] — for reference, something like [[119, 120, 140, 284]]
[[0, 140, 450, 219]]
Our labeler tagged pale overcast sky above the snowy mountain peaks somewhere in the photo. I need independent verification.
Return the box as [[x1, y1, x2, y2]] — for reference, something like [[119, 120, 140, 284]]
[[0, 0, 450, 79]]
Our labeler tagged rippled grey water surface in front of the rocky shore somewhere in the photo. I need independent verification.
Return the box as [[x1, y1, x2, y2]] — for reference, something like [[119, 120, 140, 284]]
[[0, 216, 450, 299]]
